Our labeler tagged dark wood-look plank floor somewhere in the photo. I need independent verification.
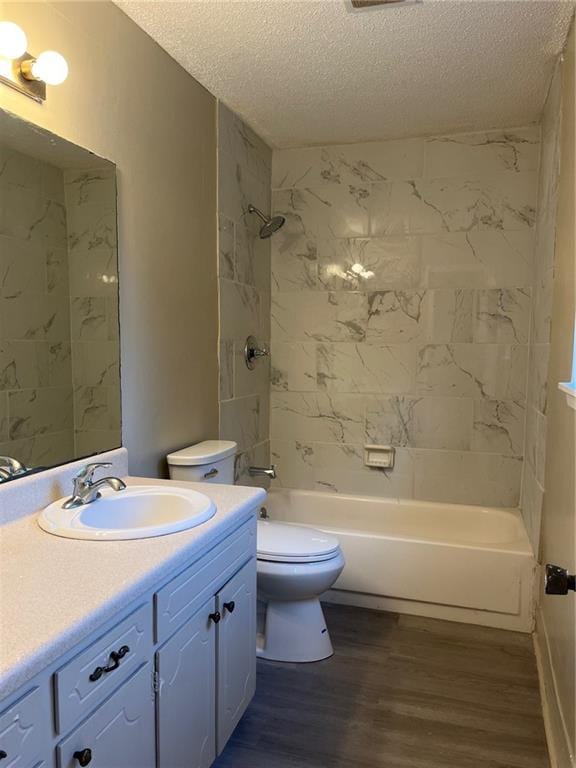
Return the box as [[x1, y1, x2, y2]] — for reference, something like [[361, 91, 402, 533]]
[[214, 606, 548, 768]]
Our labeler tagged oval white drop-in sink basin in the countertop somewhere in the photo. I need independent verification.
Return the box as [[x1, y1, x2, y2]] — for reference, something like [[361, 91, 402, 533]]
[[38, 485, 216, 541]]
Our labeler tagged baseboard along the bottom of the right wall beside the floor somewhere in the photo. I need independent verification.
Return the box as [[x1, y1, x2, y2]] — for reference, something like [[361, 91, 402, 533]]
[[534, 606, 576, 768]]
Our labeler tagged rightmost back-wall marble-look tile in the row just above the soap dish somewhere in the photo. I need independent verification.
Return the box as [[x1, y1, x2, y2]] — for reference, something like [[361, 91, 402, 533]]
[[471, 400, 526, 456]]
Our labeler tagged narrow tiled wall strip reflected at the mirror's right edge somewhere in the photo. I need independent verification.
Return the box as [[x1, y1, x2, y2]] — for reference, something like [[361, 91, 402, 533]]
[[64, 167, 121, 456]]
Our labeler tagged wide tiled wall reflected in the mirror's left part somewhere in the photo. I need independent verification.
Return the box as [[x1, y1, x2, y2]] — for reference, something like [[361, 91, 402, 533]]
[[0, 148, 74, 466]]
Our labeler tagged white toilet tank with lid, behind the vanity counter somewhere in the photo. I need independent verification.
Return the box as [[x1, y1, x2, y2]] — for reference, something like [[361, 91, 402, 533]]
[[166, 440, 238, 485]]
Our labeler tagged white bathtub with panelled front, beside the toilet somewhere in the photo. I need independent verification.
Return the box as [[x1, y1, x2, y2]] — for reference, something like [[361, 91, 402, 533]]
[[266, 490, 536, 632]]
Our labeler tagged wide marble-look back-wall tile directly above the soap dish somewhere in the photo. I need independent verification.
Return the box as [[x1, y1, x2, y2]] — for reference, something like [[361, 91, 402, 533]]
[[366, 396, 473, 451]]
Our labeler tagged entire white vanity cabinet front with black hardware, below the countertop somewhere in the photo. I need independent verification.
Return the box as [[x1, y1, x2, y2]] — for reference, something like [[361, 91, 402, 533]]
[[0, 513, 256, 768]]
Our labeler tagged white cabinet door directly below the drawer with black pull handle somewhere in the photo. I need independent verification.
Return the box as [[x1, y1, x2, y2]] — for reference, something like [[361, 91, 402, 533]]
[[58, 664, 156, 768]]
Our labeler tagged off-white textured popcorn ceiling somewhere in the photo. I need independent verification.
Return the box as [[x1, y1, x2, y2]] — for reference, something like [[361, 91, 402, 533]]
[[118, 0, 574, 147]]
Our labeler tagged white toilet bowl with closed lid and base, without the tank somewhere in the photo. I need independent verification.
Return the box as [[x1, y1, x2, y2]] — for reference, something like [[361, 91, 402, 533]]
[[256, 520, 344, 662]]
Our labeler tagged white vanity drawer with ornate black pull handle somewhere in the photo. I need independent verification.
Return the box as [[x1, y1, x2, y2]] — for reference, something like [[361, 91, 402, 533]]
[[54, 604, 152, 733]]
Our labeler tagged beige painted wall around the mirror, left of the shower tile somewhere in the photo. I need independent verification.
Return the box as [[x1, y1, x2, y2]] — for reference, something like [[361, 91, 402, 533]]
[[0, 2, 218, 475]]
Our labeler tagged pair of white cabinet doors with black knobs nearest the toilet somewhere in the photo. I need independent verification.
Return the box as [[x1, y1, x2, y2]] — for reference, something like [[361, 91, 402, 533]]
[[156, 558, 256, 768]]
